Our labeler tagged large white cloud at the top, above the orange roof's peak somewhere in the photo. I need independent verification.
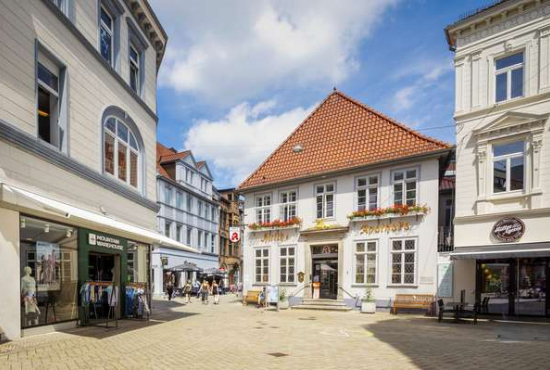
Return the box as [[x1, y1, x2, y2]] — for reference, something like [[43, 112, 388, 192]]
[[151, 0, 399, 105]]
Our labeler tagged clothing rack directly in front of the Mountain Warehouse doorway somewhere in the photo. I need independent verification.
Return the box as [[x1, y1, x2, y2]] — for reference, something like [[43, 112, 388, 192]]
[[81, 281, 120, 329]]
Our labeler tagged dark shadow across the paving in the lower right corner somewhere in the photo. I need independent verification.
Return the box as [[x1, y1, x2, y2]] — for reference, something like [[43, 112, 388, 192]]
[[363, 317, 550, 369]]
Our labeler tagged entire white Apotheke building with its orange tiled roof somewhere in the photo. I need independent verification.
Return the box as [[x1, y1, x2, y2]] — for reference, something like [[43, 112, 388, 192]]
[[239, 91, 451, 307]]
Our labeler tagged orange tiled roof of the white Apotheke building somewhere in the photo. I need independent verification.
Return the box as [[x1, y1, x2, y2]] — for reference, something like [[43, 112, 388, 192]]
[[239, 90, 451, 190]]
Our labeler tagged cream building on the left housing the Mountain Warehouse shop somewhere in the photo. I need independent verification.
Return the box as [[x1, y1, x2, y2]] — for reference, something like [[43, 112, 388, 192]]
[[0, 0, 196, 339]]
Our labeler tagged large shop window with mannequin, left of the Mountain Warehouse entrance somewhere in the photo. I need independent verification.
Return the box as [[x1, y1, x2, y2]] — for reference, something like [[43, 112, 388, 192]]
[[20, 216, 78, 328]]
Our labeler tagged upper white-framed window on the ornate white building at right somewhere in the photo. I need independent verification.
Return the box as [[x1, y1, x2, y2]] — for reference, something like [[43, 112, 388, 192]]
[[495, 52, 524, 103]]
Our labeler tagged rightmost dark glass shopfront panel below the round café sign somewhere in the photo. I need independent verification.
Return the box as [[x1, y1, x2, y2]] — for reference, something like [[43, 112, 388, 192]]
[[516, 258, 548, 316]]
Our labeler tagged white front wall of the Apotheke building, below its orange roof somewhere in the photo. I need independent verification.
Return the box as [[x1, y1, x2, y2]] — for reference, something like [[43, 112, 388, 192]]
[[243, 156, 446, 306]]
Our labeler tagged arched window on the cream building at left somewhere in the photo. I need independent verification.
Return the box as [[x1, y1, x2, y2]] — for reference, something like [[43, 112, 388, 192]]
[[103, 116, 142, 189]]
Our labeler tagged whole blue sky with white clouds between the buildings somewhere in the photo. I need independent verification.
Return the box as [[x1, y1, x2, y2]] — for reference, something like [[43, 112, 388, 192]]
[[151, 0, 486, 188]]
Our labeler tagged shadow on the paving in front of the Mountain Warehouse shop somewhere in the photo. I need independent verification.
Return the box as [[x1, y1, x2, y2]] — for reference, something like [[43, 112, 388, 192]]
[[62, 300, 198, 339]]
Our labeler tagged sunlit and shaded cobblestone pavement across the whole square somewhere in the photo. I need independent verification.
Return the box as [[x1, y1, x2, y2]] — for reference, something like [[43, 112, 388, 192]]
[[0, 296, 550, 370]]
